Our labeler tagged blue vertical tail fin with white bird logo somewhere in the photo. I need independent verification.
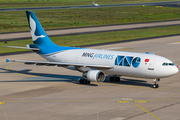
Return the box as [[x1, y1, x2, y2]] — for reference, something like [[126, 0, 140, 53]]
[[26, 11, 56, 46]]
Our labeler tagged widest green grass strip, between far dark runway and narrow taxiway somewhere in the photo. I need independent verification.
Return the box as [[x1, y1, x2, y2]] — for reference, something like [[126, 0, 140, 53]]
[[0, 6, 180, 33]]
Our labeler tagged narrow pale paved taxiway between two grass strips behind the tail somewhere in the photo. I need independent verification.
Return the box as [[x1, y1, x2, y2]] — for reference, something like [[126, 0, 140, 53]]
[[0, 20, 180, 42]]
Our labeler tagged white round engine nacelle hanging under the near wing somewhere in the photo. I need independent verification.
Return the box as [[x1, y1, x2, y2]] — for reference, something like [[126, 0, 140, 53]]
[[83, 70, 105, 82]]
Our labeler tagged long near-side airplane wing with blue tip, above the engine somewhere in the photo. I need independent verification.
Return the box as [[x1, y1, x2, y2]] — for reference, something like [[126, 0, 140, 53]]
[[6, 59, 113, 69]]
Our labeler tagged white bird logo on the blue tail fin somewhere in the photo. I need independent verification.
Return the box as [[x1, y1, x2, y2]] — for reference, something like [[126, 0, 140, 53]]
[[29, 15, 45, 41]]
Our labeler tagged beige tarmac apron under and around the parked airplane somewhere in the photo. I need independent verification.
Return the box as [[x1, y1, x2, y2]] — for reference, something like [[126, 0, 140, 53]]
[[0, 36, 180, 120]]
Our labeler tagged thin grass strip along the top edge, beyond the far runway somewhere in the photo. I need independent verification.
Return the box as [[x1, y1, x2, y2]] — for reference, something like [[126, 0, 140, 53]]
[[0, 0, 177, 8]]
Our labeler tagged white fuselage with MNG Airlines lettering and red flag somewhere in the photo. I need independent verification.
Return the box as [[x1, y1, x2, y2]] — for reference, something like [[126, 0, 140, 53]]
[[41, 49, 178, 79]]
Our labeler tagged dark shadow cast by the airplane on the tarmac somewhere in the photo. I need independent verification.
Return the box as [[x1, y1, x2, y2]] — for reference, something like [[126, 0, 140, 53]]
[[0, 68, 152, 87]]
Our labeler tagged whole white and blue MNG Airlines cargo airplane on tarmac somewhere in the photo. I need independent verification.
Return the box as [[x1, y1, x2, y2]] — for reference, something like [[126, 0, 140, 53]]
[[5, 11, 179, 88]]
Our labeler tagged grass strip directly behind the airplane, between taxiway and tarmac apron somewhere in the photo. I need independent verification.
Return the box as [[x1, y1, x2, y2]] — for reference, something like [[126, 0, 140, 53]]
[[0, 26, 180, 53]]
